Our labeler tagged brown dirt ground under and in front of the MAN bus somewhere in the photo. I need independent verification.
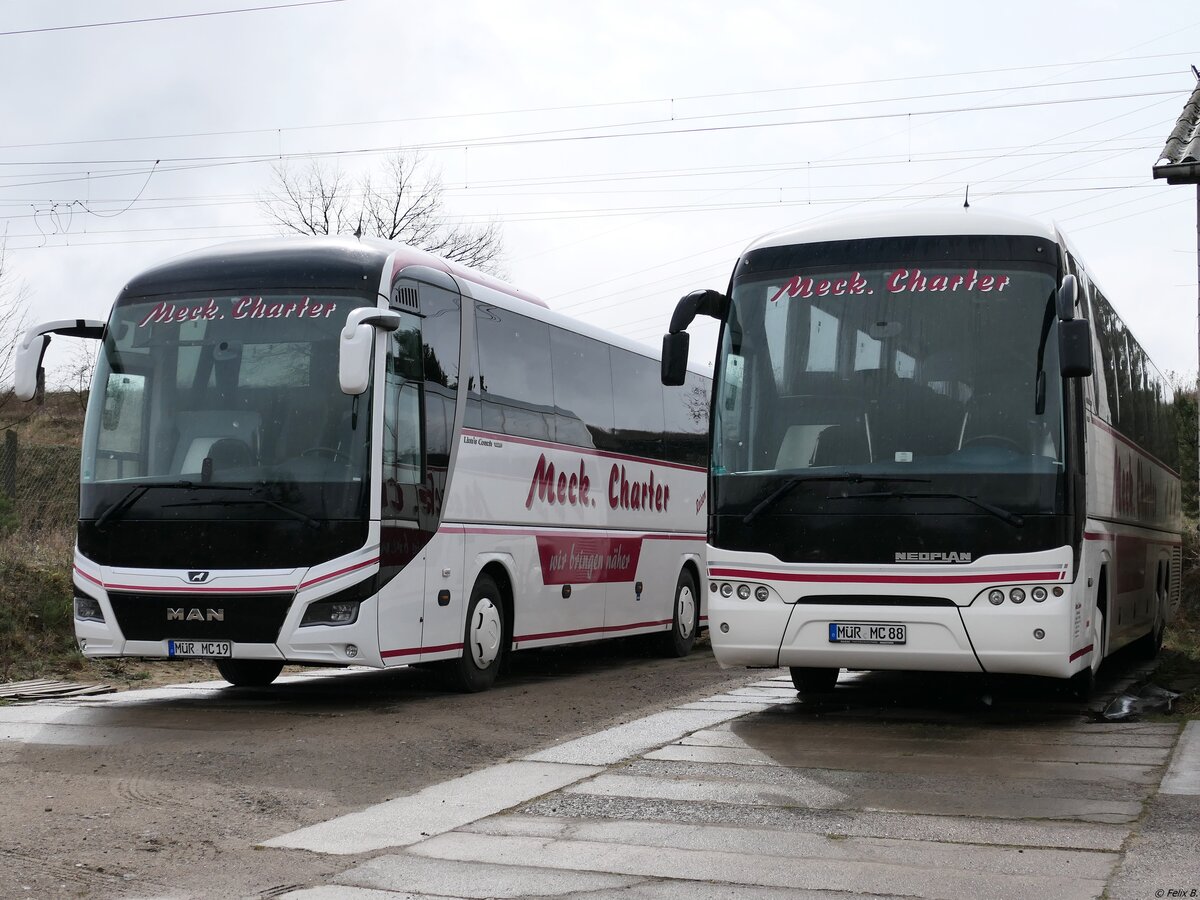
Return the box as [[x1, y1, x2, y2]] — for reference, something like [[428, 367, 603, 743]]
[[0, 640, 761, 899]]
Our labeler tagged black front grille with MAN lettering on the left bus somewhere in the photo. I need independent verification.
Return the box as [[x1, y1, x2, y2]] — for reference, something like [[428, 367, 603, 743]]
[[108, 592, 292, 643]]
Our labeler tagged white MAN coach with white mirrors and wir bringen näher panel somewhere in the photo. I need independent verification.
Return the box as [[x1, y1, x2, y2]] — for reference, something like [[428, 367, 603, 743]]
[[17, 239, 709, 690]]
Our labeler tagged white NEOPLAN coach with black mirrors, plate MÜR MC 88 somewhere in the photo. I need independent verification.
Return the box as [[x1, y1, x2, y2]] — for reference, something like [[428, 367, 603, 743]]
[[664, 210, 1181, 695]]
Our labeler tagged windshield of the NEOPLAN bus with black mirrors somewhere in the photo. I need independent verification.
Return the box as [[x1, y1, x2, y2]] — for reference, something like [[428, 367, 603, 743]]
[[713, 238, 1064, 512]]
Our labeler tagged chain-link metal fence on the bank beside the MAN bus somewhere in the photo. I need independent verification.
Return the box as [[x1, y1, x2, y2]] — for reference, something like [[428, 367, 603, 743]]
[[0, 430, 79, 534]]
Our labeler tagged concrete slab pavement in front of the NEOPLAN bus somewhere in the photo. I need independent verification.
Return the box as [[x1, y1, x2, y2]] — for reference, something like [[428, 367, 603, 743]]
[[274, 676, 1200, 900]]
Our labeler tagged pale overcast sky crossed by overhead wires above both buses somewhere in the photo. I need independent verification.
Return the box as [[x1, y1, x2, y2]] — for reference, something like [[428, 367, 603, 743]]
[[0, 0, 1200, 381]]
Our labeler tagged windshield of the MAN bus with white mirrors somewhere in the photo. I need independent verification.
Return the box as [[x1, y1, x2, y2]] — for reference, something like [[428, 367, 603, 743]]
[[80, 292, 372, 520]]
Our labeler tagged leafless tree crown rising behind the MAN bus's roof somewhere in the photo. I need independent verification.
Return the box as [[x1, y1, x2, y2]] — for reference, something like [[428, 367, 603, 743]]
[[260, 152, 503, 275]]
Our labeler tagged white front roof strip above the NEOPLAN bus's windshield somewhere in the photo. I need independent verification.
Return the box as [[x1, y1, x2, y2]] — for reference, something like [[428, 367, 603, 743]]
[[745, 209, 1056, 252]]
